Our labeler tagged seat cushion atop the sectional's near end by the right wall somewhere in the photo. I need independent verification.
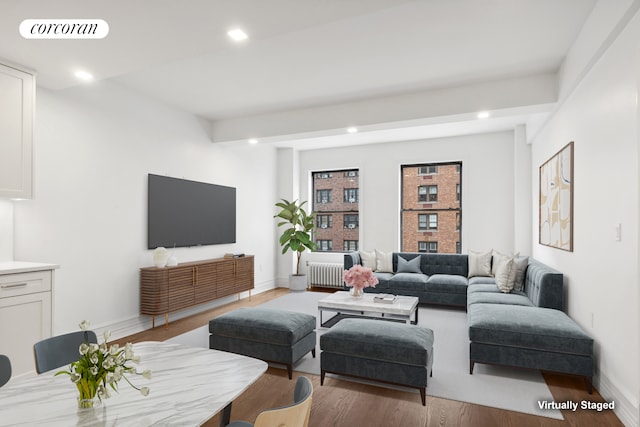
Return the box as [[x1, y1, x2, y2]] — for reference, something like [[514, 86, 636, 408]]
[[467, 304, 593, 356]]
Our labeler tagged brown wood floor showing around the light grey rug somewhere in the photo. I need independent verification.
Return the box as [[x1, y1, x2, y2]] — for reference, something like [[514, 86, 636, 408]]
[[116, 288, 623, 427]]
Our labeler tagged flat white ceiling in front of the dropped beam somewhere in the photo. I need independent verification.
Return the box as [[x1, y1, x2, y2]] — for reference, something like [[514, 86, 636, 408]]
[[0, 0, 596, 149]]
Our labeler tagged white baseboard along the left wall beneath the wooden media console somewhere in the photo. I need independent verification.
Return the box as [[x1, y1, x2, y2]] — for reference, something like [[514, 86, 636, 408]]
[[91, 280, 276, 341]]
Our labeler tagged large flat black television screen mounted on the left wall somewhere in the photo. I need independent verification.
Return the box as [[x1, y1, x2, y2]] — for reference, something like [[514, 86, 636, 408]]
[[147, 174, 236, 249]]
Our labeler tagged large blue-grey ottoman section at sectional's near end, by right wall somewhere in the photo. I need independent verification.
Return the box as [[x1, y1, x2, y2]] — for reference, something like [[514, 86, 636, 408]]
[[467, 304, 594, 393]]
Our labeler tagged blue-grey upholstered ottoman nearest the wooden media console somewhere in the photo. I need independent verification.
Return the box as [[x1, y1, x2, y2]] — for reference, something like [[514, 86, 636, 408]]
[[209, 307, 316, 379]]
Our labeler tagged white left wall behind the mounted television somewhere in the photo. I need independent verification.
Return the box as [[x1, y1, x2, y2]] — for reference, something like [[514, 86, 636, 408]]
[[14, 82, 276, 333]]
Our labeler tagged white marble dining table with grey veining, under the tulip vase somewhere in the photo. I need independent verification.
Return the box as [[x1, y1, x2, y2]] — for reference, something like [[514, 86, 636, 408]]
[[0, 341, 267, 427]]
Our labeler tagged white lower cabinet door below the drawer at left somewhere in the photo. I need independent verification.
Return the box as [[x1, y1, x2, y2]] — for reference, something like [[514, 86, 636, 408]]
[[0, 292, 51, 376]]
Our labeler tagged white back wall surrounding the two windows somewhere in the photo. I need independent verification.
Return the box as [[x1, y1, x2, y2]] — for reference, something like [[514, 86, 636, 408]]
[[300, 132, 530, 253]]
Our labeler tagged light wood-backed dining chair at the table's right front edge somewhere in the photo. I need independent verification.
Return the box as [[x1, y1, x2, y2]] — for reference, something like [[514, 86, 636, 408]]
[[227, 377, 313, 427]]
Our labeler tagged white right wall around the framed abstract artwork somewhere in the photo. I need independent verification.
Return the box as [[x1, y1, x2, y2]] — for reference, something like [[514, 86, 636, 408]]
[[531, 8, 640, 425]]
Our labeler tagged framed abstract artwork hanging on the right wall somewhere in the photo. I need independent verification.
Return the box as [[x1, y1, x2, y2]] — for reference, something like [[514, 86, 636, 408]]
[[539, 142, 573, 252]]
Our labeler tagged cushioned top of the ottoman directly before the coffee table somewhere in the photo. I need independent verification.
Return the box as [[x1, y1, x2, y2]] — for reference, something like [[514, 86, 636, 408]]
[[320, 319, 433, 366]]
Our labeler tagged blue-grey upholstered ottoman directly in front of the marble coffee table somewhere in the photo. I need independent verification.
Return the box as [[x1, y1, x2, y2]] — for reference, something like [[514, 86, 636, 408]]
[[320, 319, 433, 406]]
